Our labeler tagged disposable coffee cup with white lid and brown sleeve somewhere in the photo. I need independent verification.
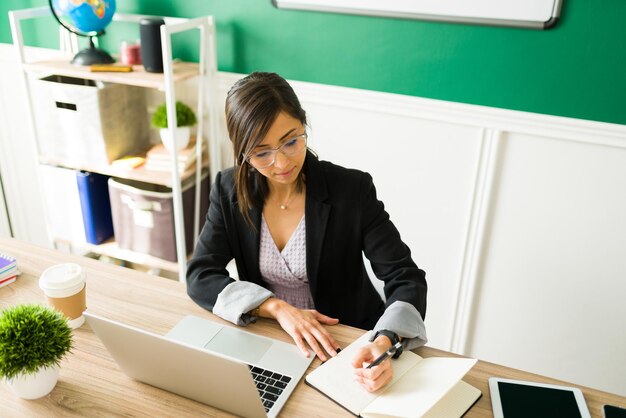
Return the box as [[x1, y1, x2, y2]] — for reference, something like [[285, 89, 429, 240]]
[[39, 263, 87, 329]]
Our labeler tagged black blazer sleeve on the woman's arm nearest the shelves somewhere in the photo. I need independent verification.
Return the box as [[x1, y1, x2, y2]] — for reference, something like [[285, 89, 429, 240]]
[[187, 173, 235, 311]]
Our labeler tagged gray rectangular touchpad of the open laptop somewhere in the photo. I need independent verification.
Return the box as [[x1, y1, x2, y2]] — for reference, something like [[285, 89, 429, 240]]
[[204, 327, 272, 364]]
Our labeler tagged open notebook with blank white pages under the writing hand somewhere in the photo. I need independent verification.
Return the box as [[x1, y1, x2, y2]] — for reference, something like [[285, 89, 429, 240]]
[[306, 333, 481, 418]]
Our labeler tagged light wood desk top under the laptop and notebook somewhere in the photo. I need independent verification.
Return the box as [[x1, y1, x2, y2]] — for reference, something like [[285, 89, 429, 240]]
[[0, 238, 626, 418]]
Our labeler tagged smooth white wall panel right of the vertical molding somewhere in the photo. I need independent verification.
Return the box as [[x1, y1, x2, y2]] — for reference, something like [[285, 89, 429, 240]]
[[467, 134, 626, 394]]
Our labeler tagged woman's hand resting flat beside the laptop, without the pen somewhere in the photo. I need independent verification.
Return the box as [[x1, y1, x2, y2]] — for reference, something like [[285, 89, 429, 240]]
[[259, 297, 339, 361]]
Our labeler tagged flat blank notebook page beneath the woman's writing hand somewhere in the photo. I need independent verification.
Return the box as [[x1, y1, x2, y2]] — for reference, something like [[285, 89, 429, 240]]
[[306, 332, 422, 415]]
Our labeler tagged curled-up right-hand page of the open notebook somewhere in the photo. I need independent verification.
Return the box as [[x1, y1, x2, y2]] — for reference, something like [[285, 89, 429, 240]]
[[361, 357, 476, 418]]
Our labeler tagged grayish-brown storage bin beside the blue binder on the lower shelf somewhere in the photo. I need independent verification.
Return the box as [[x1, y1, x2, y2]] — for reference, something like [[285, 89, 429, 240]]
[[109, 172, 209, 261]]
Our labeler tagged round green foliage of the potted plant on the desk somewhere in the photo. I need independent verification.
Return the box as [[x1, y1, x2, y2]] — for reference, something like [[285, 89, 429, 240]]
[[0, 304, 73, 379]]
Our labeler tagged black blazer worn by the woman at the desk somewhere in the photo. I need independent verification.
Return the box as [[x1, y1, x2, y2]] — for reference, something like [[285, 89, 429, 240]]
[[187, 153, 426, 329]]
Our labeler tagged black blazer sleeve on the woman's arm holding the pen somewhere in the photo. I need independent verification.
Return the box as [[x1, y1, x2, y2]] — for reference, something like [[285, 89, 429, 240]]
[[360, 173, 427, 318]]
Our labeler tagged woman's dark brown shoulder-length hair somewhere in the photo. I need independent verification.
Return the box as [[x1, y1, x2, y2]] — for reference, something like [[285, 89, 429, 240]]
[[225, 72, 307, 225]]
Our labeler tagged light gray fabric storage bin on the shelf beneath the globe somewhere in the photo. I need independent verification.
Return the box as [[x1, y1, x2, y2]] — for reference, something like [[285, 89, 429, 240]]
[[33, 75, 150, 165]]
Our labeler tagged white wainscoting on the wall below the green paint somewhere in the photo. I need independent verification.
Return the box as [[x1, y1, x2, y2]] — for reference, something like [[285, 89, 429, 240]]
[[0, 45, 626, 395]]
